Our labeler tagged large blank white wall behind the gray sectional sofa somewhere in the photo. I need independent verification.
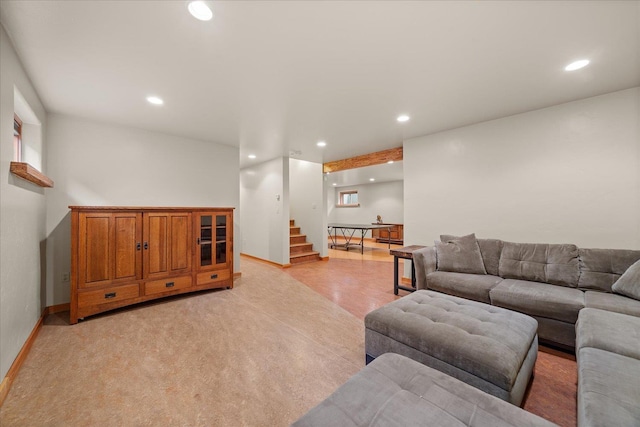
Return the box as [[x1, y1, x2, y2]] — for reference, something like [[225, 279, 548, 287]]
[[404, 88, 640, 249]]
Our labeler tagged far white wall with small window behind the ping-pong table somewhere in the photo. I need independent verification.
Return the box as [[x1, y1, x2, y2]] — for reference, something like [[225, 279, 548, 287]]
[[328, 181, 404, 237]]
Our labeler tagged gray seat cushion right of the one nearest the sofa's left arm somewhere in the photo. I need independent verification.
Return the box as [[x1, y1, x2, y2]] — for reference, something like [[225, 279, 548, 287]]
[[489, 279, 584, 323]]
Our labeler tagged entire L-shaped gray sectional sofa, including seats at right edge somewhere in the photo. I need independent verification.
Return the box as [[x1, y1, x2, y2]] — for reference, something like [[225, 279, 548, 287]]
[[413, 235, 640, 427]]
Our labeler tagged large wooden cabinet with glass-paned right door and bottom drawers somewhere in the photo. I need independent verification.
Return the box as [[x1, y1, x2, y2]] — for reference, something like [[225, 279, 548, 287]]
[[70, 206, 233, 324]]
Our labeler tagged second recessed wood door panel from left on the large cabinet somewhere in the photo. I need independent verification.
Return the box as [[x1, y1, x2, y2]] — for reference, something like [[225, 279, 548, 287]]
[[114, 216, 139, 279]]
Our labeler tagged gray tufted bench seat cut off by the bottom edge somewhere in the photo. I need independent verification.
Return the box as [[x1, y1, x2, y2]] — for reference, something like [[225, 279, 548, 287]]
[[293, 353, 555, 427]]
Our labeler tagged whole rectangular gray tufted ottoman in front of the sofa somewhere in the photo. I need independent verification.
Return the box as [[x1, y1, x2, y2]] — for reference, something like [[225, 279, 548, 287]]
[[364, 290, 538, 406]]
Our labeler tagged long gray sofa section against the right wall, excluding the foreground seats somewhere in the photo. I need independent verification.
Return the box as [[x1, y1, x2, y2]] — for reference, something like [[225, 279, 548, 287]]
[[413, 235, 640, 349]]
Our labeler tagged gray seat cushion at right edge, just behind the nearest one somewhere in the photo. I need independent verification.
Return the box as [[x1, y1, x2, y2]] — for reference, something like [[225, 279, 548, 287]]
[[576, 308, 640, 360]]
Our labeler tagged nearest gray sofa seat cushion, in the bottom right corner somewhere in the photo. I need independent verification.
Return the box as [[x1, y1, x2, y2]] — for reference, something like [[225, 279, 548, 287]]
[[576, 347, 640, 427]]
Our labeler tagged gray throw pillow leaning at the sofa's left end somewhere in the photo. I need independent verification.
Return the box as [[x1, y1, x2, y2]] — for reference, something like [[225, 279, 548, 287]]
[[436, 234, 487, 274]]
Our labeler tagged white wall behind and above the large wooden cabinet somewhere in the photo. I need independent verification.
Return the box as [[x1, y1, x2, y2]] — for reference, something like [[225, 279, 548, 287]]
[[47, 115, 240, 305]]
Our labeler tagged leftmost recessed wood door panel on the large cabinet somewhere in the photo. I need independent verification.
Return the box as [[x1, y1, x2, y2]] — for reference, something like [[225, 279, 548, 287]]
[[80, 215, 111, 283]]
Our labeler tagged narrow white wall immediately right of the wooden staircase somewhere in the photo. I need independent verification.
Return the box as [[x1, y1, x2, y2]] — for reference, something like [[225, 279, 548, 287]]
[[289, 159, 328, 257]]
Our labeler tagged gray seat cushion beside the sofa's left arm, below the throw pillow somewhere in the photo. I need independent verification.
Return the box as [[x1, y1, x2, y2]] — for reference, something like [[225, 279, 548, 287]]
[[427, 271, 503, 304]]
